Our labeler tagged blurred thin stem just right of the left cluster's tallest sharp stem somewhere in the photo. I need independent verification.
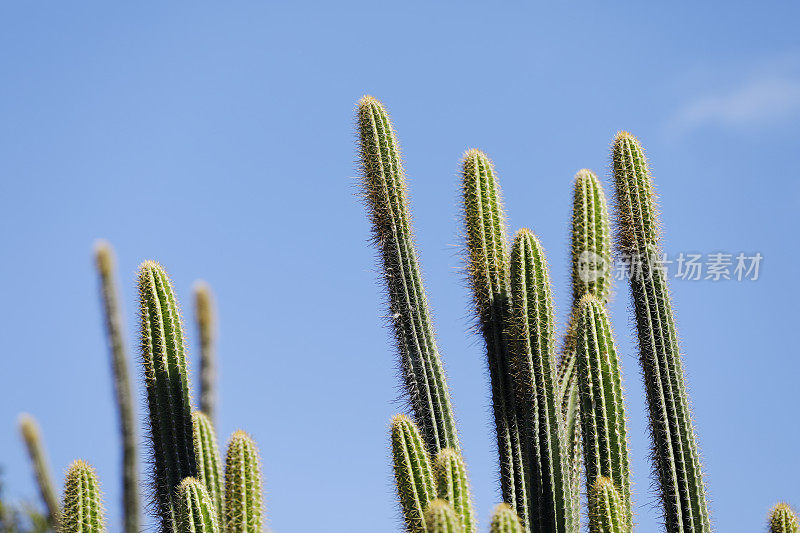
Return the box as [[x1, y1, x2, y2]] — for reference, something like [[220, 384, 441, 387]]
[[194, 281, 217, 423]]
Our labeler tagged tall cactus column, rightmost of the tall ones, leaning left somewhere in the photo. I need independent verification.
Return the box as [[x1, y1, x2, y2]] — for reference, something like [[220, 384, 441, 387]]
[[612, 132, 711, 533]]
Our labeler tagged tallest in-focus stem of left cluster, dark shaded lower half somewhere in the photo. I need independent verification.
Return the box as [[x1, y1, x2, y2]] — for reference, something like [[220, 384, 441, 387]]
[[138, 261, 197, 532]]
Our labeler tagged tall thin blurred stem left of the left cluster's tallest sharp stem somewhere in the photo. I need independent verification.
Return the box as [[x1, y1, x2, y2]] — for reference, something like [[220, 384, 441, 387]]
[[95, 241, 140, 533]]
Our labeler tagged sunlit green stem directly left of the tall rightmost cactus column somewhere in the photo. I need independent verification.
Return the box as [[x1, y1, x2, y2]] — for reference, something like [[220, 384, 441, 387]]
[[575, 294, 633, 531]]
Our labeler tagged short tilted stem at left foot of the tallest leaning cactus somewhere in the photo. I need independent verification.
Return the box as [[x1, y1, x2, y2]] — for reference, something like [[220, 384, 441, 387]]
[[390, 415, 436, 533]]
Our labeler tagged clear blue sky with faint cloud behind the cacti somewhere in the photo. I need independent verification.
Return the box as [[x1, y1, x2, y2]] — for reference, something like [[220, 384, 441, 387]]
[[0, 2, 800, 532]]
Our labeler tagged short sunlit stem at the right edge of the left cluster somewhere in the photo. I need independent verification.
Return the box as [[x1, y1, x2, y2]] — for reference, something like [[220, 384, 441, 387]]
[[225, 431, 264, 533]]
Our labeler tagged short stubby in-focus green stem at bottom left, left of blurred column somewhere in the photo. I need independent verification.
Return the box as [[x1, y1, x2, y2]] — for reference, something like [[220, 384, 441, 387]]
[[58, 460, 106, 533]]
